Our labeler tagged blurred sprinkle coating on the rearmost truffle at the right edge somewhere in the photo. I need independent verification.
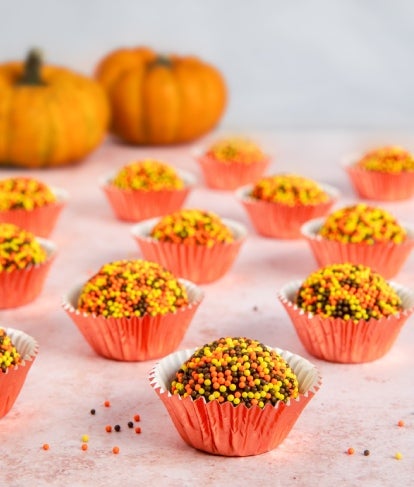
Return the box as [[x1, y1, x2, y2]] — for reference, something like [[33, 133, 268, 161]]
[[356, 146, 414, 174]]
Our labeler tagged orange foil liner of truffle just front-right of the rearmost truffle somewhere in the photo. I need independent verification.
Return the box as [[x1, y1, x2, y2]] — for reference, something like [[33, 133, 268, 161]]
[[236, 184, 339, 239]]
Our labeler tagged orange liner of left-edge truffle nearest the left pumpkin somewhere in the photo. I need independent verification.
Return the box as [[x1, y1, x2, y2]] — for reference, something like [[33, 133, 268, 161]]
[[0, 187, 68, 237]]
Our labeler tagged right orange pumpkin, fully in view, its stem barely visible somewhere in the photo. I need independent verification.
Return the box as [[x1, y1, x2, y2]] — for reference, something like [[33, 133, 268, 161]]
[[96, 47, 227, 145]]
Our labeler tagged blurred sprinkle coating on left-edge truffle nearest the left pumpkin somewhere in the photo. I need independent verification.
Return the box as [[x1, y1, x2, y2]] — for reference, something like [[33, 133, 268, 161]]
[[0, 177, 56, 211]]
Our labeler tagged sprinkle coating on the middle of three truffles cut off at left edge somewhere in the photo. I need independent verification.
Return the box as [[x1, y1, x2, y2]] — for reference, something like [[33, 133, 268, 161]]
[[0, 223, 47, 272]]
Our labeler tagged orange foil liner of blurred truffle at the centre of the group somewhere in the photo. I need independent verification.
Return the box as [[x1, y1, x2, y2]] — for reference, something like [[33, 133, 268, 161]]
[[131, 218, 247, 284]]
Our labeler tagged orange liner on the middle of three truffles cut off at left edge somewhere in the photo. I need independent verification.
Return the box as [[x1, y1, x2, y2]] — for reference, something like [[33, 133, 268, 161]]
[[0, 237, 56, 309]]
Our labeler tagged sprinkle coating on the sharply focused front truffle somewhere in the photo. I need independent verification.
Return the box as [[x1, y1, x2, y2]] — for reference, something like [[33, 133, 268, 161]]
[[170, 337, 299, 408]]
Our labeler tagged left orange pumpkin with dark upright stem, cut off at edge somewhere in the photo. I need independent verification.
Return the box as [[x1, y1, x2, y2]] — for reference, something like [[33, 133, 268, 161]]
[[0, 50, 110, 168]]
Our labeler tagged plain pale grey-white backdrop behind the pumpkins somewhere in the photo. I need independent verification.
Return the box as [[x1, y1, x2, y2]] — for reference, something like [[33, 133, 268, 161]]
[[0, 0, 414, 130]]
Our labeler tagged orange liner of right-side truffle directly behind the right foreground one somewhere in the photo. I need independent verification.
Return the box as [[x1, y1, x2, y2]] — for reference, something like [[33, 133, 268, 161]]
[[301, 218, 414, 279]]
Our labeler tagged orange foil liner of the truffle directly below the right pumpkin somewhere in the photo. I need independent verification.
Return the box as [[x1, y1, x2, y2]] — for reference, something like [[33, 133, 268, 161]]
[[101, 170, 195, 222]]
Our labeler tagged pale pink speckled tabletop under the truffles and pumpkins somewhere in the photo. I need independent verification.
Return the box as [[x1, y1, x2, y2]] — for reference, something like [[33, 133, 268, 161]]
[[0, 131, 414, 487]]
